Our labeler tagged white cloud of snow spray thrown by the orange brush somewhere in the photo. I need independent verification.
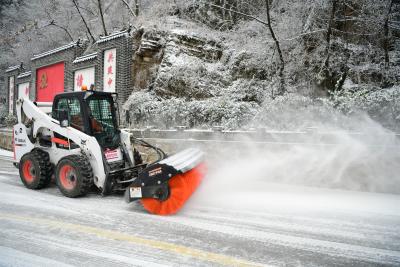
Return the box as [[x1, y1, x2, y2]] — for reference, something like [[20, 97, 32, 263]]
[[188, 112, 400, 215]]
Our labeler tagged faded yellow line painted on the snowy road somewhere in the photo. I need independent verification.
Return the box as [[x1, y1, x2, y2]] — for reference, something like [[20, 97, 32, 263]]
[[0, 213, 264, 266]]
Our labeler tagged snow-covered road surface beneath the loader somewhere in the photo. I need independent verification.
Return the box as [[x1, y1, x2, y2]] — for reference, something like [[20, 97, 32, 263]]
[[0, 153, 400, 266]]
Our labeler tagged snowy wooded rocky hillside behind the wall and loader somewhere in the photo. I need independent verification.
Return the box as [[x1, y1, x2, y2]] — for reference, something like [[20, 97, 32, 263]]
[[0, 0, 400, 130]]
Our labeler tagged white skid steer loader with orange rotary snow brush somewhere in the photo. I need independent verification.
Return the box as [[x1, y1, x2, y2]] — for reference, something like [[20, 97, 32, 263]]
[[13, 91, 205, 215]]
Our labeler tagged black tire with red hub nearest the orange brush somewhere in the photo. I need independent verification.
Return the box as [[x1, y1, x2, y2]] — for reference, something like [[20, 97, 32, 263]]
[[55, 155, 93, 197]]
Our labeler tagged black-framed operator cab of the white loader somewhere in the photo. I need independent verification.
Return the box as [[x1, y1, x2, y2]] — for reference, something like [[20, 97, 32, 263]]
[[52, 91, 120, 149]]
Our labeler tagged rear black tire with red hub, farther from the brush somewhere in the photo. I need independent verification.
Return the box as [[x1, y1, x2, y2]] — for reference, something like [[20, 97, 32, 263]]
[[18, 149, 53, 189]]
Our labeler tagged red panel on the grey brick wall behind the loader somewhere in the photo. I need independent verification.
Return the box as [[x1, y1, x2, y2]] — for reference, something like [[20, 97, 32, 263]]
[[36, 62, 64, 102]]
